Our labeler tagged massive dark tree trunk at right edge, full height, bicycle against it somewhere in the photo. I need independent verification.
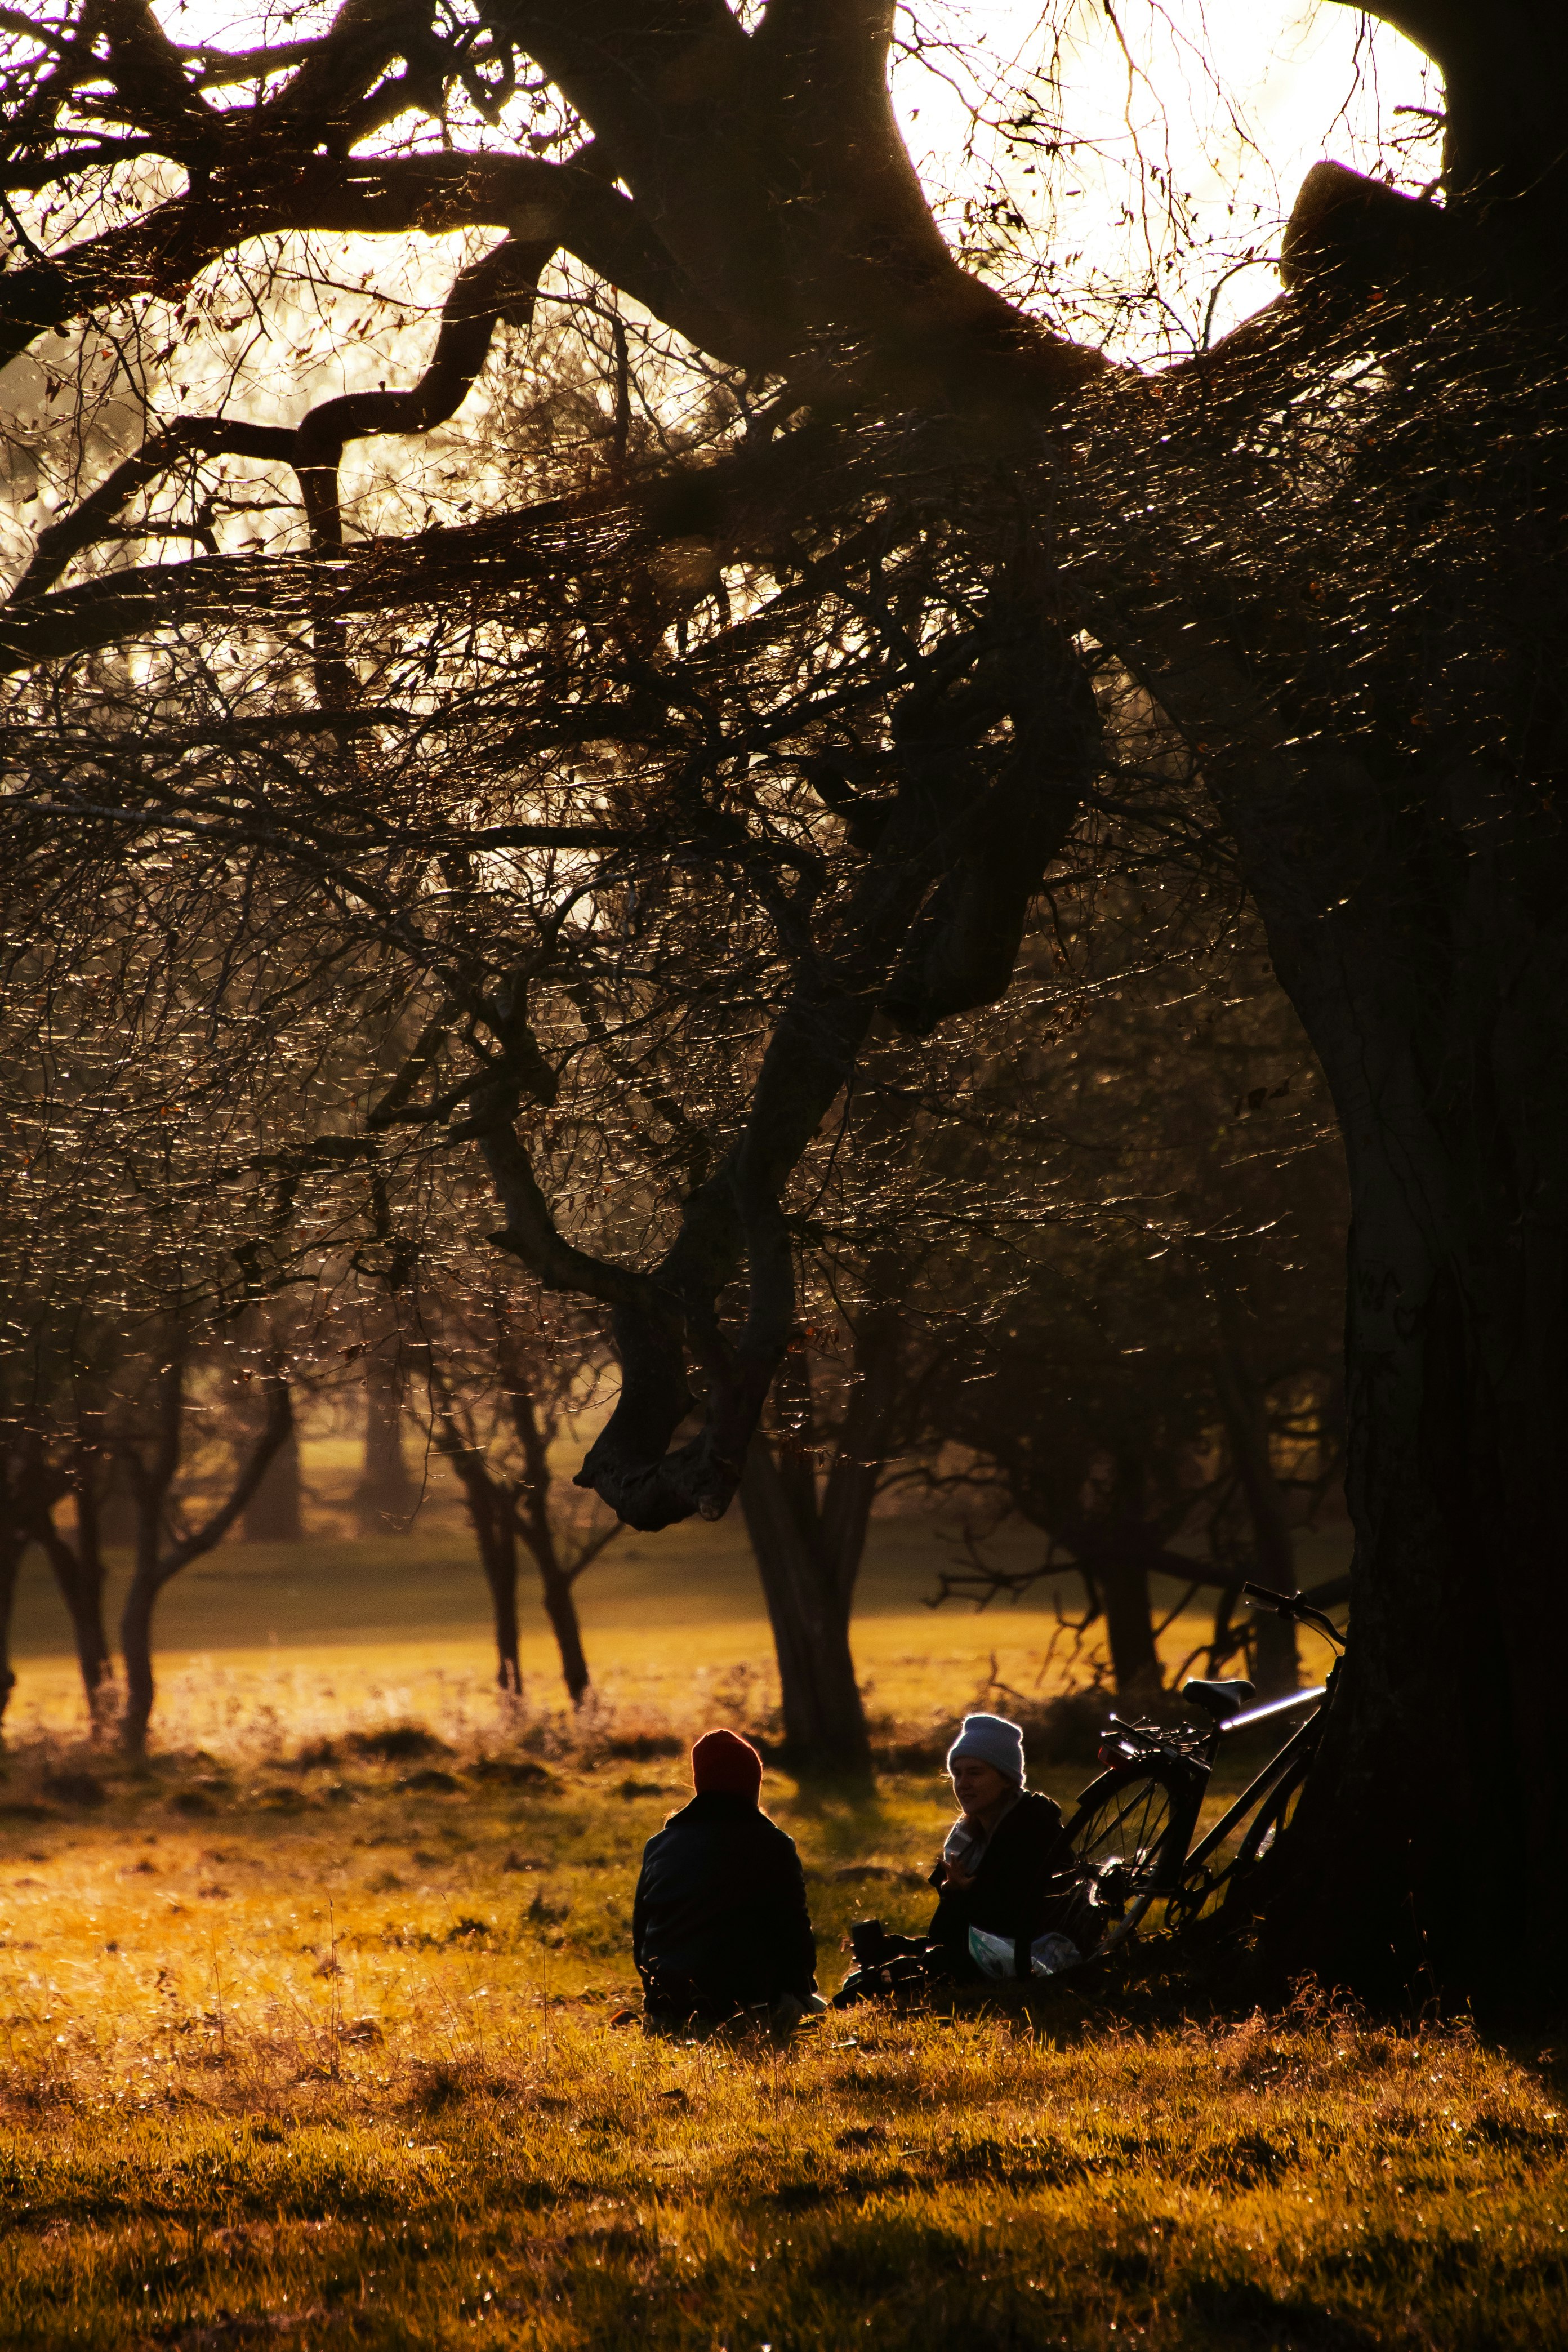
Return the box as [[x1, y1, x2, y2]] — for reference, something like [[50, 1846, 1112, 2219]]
[[1053, 0, 1568, 2004]]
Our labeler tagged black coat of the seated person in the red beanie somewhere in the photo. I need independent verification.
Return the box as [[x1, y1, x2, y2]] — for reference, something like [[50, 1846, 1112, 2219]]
[[632, 1790, 816, 2014]]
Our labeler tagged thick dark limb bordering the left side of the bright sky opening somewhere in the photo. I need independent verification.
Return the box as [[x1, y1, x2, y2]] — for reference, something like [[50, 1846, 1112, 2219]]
[[501, 0, 1105, 407]]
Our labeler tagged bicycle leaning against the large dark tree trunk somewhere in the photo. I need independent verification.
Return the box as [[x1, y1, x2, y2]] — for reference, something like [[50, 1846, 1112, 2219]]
[[1063, 1585, 1344, 1959]]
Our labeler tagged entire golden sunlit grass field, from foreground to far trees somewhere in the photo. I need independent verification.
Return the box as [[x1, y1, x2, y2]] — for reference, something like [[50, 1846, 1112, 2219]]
[[0, 1522, 1568, 2352]]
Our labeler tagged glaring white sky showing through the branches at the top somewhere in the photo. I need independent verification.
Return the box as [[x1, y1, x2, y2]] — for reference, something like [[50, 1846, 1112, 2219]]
[[144, 0, 1438, 358]]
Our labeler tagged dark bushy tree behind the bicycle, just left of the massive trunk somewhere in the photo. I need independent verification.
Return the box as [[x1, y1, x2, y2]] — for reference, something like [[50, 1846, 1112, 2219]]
[[929, 898, 1344, 1698]]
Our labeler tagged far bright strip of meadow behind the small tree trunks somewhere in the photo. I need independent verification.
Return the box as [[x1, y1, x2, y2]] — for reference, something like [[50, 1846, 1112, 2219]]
[[5, 1512, 1344, 1745]]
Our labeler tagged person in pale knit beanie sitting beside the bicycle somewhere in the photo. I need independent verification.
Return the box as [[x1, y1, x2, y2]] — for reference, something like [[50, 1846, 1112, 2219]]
[[926, 1714, 1063, 1978]]
